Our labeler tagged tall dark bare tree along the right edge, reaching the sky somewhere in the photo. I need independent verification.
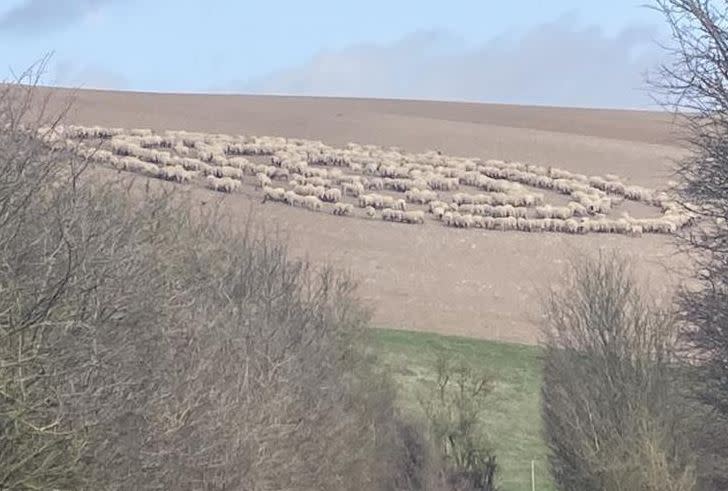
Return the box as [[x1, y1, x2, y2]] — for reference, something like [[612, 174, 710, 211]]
[[652, 0, 728, 489]]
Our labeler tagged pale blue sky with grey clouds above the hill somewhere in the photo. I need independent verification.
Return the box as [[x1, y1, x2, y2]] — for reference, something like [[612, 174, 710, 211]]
[[0, 0, 665, 109]]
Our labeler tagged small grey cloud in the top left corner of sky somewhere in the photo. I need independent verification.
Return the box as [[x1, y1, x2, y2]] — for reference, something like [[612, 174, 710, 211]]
[[0, 0, 114, 34]]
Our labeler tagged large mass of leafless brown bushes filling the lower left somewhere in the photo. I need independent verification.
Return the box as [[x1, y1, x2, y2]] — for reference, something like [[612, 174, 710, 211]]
[[0, 66, 432, 490]]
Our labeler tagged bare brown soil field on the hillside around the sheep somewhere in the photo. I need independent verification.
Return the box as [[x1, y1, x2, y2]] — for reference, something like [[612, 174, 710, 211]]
[[44, 87, 682, 343]]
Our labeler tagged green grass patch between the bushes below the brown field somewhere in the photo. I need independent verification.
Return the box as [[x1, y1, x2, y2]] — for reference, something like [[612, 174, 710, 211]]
[[374, 329, 554, 491]]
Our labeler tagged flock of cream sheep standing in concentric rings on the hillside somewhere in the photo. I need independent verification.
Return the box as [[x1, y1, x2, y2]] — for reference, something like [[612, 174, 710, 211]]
[[41, 126, 692, 235]]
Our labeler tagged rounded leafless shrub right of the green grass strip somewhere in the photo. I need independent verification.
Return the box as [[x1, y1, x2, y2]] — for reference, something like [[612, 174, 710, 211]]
[[542, 255, 695, 491]]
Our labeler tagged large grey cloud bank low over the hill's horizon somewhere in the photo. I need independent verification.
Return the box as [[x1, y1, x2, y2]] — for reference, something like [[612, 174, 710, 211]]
[[236, 14, 662, 108]]
